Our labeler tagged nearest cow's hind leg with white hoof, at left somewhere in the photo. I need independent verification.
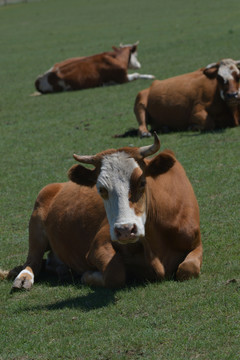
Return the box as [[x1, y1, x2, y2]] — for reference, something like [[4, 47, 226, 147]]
[[10, 214, 49, 290]]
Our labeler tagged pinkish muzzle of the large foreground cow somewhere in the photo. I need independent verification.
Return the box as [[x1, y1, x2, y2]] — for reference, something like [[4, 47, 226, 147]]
[[114, 223, 139, 244]]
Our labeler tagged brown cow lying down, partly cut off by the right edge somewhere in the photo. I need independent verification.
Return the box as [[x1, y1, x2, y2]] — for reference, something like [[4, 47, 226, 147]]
[[134, 59, 240, 137]]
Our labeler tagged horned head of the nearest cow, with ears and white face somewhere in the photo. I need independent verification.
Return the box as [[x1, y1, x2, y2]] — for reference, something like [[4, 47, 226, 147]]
[[69, 134, 175, 244]]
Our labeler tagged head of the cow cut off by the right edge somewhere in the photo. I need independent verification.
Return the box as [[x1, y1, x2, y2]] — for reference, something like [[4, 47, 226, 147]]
[[203, 59, 240, 106]]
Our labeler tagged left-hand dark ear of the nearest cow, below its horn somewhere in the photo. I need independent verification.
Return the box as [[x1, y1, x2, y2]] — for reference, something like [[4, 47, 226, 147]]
[[68, 164, 98, 187]]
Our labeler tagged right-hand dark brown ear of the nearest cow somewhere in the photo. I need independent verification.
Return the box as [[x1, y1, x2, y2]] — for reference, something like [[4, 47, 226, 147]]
[[145, 150, 176, 177]]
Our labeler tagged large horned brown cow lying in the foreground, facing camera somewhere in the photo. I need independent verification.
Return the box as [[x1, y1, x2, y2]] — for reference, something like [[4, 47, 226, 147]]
[[0, 135, 202, 289]]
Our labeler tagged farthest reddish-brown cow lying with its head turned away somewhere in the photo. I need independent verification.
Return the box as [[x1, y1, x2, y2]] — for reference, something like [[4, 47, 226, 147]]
[[35, 42, 154, 94]]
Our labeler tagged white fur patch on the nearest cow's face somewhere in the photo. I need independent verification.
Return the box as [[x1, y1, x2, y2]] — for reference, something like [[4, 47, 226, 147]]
[[97, 152, 146, 241]]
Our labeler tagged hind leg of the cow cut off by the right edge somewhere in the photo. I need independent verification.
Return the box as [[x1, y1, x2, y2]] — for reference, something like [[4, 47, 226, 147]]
[[134, 89, 151, 137]]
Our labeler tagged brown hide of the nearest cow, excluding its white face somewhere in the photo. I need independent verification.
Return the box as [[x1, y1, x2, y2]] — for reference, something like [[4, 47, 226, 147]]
[[7, 138, 202, 289]]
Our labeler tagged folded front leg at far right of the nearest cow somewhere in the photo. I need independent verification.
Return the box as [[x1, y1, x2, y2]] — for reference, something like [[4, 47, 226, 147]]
[[176, 245, 202, 281]]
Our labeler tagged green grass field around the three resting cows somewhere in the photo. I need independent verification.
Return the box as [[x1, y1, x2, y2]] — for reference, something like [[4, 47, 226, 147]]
[[0, 0, 240, 360]]
